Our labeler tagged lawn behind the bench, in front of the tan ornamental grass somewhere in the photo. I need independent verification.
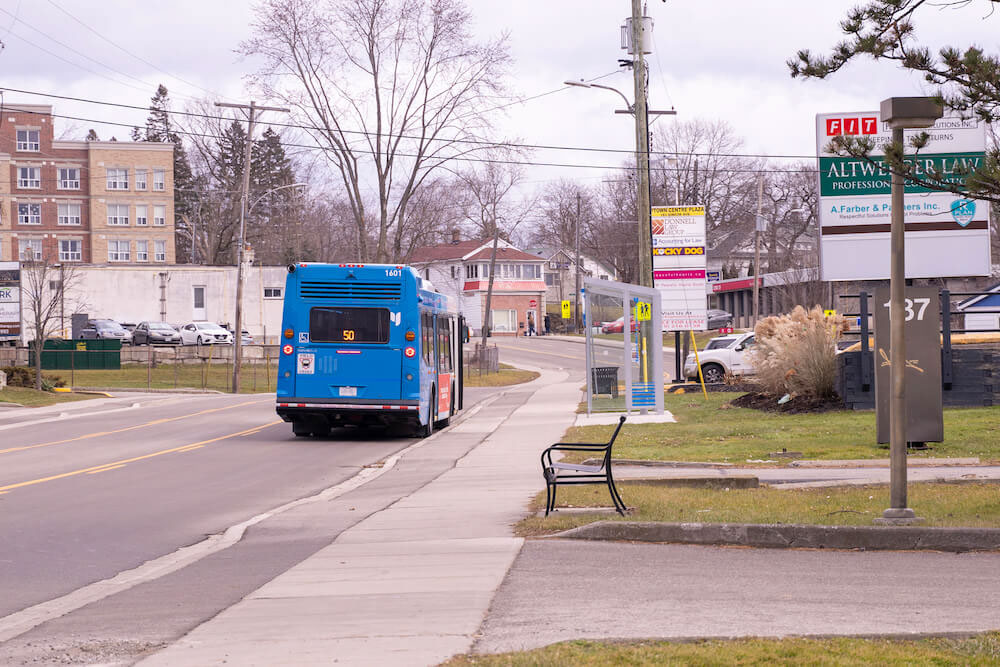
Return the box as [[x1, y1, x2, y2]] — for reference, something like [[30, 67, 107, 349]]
[[563, 392, 1000, 465]]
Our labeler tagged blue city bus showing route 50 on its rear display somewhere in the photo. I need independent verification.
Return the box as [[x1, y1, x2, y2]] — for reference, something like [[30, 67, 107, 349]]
[[277, 262, 465, 437]]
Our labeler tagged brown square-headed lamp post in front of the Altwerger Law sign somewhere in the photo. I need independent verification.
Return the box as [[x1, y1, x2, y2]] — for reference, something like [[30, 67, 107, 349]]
[[879, 97, 943, 523]]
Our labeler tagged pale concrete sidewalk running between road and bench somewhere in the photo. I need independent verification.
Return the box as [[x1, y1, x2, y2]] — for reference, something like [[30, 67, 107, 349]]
[[142, 372, 579, 665]]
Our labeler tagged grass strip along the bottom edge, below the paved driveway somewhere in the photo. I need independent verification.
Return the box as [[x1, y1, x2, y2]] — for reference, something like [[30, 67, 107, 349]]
[[444, 632, 1000, 667]]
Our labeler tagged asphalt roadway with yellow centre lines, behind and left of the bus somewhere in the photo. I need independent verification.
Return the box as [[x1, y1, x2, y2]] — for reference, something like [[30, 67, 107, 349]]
[[0, 389, 508, 618]]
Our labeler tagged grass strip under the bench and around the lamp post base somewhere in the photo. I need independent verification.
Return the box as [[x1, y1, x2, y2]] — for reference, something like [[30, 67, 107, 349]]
[[516, 481, 1000, 537]]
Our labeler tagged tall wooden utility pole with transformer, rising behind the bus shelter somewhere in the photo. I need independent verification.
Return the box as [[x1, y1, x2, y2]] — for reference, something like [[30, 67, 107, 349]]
[[632, 0, 653, 287]]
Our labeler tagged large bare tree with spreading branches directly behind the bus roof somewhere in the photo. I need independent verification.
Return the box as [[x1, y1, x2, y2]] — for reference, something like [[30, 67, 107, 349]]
[[241, 0, 510, 262]]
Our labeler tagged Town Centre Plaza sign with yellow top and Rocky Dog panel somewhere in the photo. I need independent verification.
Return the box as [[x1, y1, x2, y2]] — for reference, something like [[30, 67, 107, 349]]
[[650, 206, 708, 331]]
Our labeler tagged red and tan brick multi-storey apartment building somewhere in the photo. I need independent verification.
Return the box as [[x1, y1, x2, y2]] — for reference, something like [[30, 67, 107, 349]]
[[0, 104, 175, 265]]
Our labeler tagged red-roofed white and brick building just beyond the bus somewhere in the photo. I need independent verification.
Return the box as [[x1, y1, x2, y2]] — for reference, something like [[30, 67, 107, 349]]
[[409, 235, 545, 336]]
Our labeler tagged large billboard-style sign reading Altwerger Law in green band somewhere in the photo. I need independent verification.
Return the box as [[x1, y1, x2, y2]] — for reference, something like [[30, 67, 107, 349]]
[[816, 111, 990, 280]]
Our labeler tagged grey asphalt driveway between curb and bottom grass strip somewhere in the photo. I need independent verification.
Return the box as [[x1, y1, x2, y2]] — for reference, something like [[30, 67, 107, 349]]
[[475, 539, 1000, 653]]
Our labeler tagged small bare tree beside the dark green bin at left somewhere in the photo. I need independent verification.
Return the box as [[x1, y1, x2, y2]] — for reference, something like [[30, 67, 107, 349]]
[[21, 250, 82, 391]]
